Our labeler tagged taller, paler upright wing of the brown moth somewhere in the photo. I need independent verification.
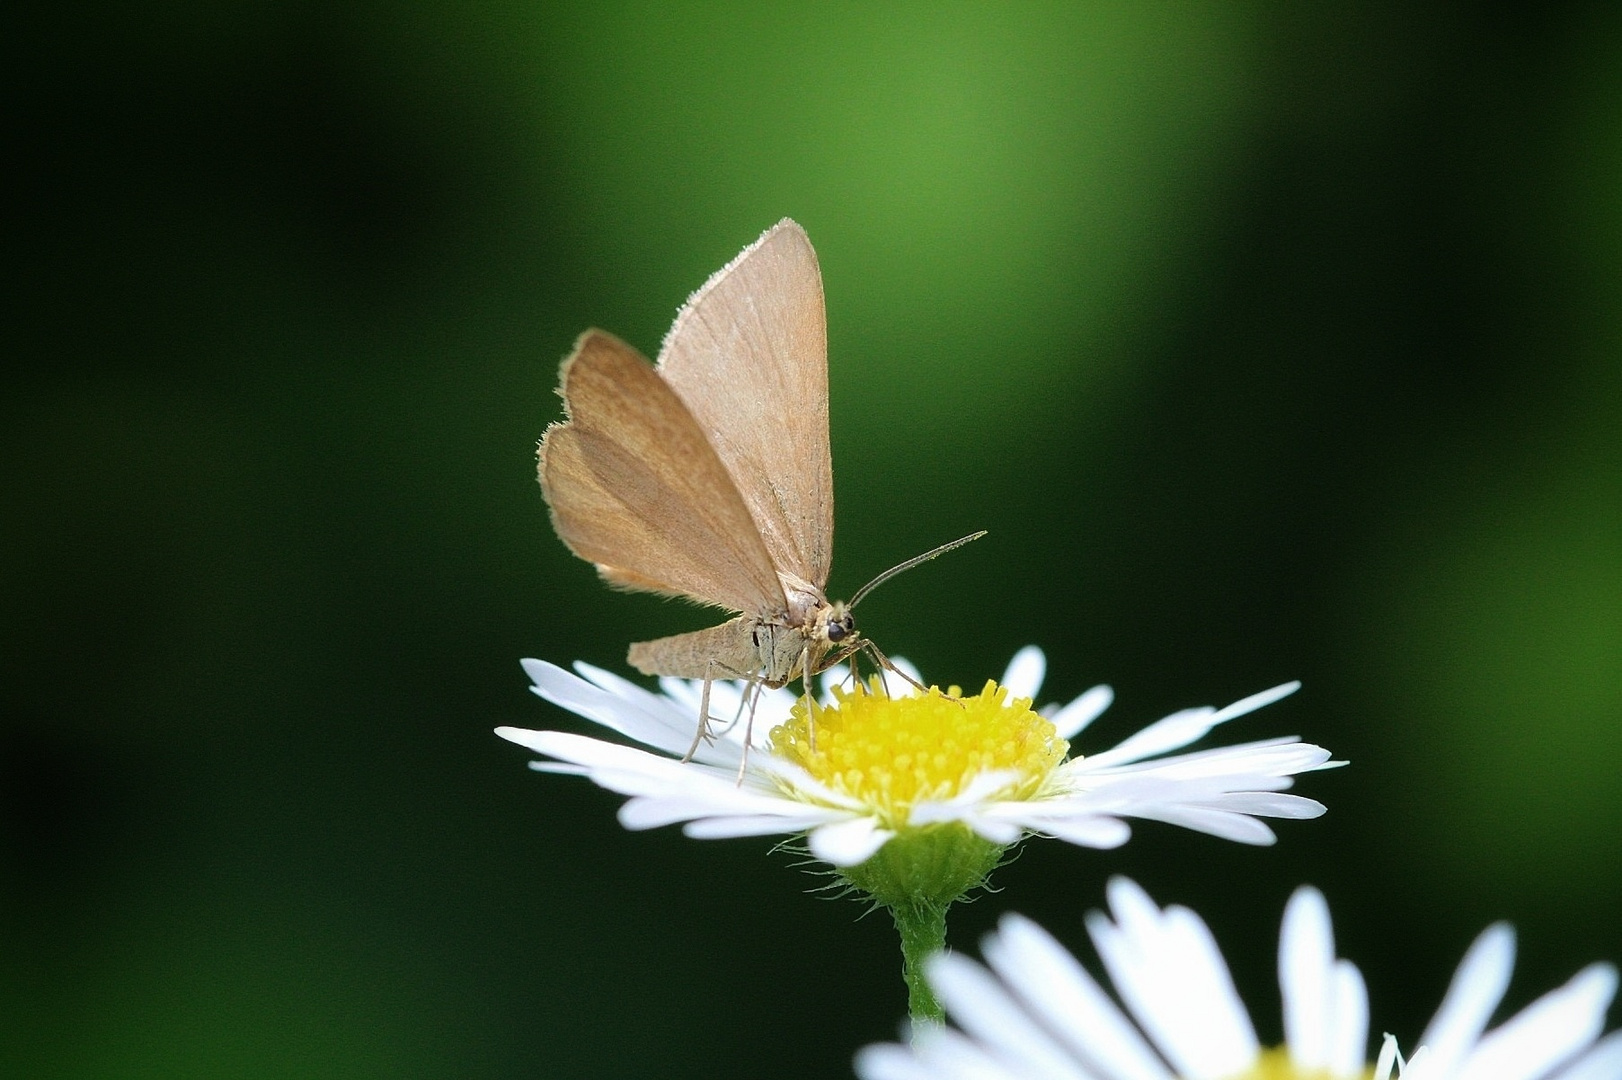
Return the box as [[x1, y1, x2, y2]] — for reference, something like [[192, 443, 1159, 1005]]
[[659, 217, 834, 589]]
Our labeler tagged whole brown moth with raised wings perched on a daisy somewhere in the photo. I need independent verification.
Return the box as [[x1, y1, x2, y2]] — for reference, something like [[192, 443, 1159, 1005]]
[[540, 219, 985, 756]]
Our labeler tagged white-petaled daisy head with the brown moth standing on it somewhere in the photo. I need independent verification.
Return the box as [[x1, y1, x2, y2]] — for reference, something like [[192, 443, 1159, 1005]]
[[496, 647, 1341, 868]]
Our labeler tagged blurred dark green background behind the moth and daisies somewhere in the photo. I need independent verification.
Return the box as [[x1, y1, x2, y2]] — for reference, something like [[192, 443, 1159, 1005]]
[[0, 0, 1622, 1078]]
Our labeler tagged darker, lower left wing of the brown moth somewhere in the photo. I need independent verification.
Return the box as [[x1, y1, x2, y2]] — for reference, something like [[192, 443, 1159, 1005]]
[[540, 331, 785, 615]]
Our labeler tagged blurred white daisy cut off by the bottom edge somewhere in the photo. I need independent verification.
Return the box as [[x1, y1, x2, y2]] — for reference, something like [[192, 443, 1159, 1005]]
[[856, 877, 1622, 1080]]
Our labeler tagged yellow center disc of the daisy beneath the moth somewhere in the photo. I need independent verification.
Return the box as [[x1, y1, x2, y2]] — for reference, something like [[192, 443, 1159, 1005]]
[[772, 679, 1071, 829]]
